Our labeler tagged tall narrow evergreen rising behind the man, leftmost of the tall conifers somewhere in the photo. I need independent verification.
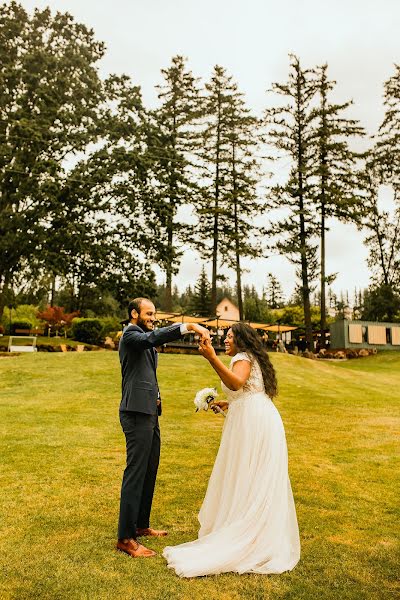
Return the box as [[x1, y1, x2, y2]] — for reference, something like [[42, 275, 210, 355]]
[[148, 56, 201, 310]]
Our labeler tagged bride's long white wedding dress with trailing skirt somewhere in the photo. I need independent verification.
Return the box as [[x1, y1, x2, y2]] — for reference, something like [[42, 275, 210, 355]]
[[163, 353, 300, 577]]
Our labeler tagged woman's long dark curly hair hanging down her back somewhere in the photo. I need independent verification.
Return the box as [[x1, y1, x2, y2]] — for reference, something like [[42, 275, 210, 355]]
[[232, 323, 278, 398]]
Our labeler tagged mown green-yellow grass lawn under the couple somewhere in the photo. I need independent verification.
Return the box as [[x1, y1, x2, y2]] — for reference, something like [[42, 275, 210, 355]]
[[0, 352, 400, 600]]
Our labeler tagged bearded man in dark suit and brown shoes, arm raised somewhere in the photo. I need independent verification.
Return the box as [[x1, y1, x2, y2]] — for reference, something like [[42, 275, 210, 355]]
[[117, 298, 210, 558]]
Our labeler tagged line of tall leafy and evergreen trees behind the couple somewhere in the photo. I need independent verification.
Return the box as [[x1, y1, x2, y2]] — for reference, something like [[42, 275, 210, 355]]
[[0, 2, 400, 347]]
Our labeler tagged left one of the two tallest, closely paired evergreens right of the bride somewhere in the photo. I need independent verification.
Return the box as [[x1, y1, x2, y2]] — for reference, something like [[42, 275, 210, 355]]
[[266, 56, 317, 350]]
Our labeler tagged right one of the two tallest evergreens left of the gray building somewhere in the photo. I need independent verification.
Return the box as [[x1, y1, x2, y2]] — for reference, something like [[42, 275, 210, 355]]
[[314, 65, 364, 348]]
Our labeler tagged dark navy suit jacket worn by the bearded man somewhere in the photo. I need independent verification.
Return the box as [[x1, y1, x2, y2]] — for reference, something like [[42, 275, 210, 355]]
[[119, 323, 182, 415]]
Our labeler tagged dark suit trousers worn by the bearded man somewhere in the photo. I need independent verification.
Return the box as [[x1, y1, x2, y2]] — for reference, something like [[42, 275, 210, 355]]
[[118, 412, 160, 539]]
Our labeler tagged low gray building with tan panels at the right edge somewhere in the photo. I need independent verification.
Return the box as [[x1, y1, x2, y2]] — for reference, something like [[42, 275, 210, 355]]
[[329, 319, 400, 350]]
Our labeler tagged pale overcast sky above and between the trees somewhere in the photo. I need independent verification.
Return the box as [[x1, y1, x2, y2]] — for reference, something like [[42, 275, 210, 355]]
[[16, 0, 400, 296]]
